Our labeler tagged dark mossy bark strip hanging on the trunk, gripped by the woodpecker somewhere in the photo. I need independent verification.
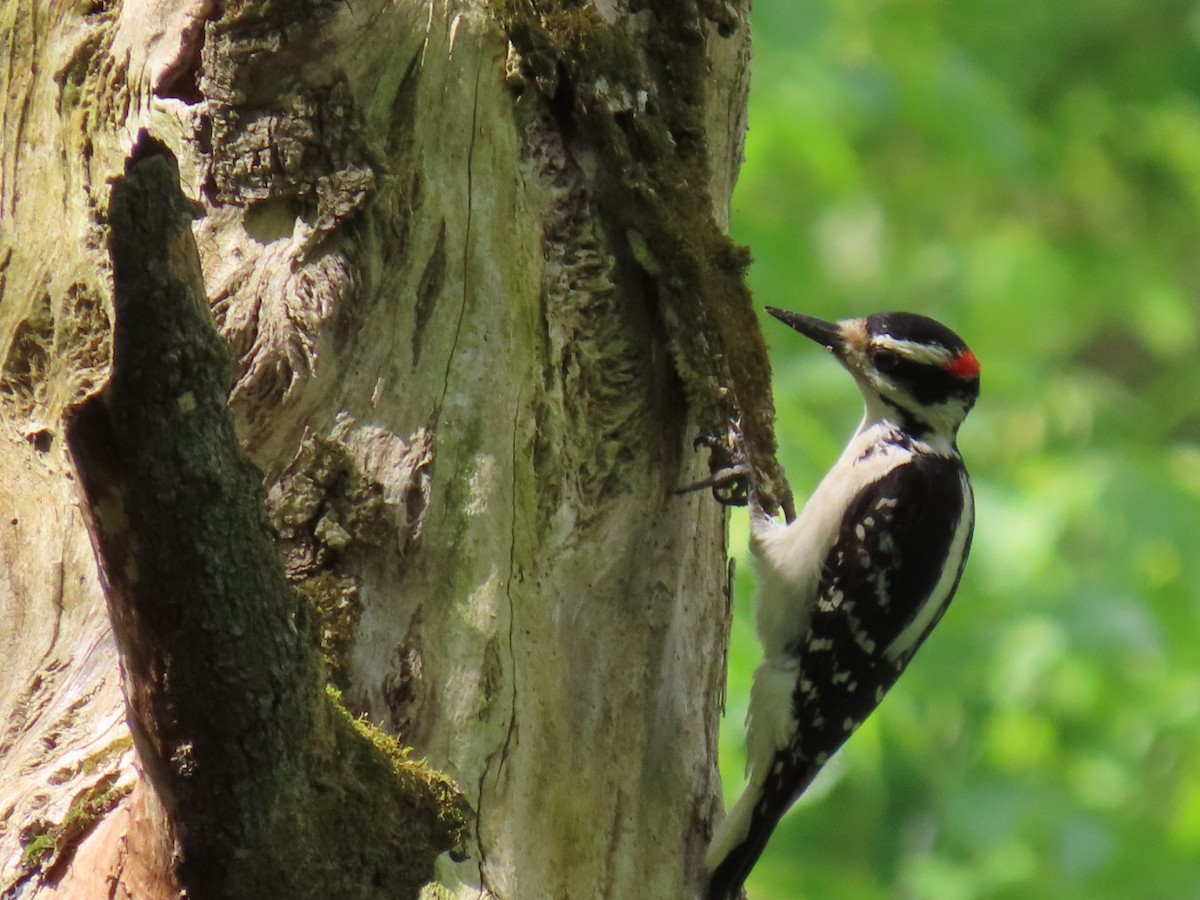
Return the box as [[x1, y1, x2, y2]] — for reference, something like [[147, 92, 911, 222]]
[[493, 0, 788, 513]]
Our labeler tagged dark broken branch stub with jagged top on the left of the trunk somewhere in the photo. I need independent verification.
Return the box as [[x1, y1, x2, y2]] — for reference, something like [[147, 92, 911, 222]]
[[68, 134, 462, 899]]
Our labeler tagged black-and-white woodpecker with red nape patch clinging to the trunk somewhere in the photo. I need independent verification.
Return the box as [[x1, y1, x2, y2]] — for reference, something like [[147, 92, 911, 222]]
[[706, 307, 979, 900]]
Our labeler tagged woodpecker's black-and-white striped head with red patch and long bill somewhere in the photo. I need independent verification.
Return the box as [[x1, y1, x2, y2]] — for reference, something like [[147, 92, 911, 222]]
[[767, 306, 979, 440]]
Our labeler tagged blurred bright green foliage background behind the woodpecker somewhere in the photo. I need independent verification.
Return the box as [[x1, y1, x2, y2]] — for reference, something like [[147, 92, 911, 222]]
[[721, 0, 1200, 900]]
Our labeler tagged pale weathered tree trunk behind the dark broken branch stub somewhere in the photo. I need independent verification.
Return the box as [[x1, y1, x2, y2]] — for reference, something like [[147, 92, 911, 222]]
[[0, 0, 768, 899]]
